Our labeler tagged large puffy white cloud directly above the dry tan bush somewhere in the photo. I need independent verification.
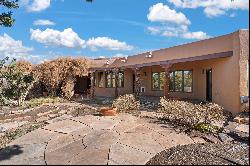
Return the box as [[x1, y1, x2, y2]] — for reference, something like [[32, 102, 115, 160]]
[[30, 28, 85, 48]]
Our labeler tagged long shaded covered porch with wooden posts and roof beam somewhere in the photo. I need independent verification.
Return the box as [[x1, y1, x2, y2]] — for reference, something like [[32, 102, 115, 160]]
[[91, 51, 233, 102]]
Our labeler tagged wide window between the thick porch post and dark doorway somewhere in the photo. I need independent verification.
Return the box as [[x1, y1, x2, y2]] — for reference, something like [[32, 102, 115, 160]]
[[169, 70, 193, 92]]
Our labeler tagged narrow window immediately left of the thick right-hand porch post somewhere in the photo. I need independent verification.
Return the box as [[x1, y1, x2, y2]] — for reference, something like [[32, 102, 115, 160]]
[[152, 72, 165, 90]]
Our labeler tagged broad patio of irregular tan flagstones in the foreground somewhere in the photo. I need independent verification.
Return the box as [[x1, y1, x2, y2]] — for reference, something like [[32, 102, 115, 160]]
[[0, 114, 197, 165]]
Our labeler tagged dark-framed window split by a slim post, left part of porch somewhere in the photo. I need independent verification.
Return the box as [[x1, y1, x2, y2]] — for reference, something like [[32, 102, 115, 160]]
[[106, 72, 124, 88]]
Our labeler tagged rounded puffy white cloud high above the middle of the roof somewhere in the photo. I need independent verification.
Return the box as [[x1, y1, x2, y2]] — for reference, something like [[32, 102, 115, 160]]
[[147, 3, 190, 25]]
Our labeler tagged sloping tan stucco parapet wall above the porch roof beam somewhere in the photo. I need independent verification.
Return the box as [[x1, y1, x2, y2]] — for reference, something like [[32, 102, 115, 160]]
[[114, 33, 233, 66]]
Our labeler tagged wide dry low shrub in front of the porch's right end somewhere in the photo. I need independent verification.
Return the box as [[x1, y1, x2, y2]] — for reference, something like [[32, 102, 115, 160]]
[[158, 97, 225, 127]]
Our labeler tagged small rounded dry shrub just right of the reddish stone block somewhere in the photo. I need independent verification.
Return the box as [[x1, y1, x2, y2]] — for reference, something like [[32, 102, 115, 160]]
[[112, 94, 140, 112]]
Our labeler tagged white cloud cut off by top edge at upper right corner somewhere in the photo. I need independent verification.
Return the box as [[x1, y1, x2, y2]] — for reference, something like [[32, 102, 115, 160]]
[[168, 0, 249, 17]]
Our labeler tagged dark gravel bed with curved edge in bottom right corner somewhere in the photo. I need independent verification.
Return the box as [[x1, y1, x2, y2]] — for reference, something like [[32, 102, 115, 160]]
[[146, 143, 249, 165]]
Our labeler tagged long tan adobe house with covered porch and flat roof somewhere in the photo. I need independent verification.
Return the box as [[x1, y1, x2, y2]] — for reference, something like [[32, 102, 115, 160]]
[[91, 30, 249, 113]]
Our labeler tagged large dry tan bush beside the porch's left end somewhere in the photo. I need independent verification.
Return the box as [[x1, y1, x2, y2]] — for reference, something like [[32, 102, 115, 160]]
[[32, 58, 89, 98]]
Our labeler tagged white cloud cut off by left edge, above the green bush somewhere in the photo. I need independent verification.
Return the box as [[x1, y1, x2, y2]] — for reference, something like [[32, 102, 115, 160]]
[[0, 34, 33, 59]]
